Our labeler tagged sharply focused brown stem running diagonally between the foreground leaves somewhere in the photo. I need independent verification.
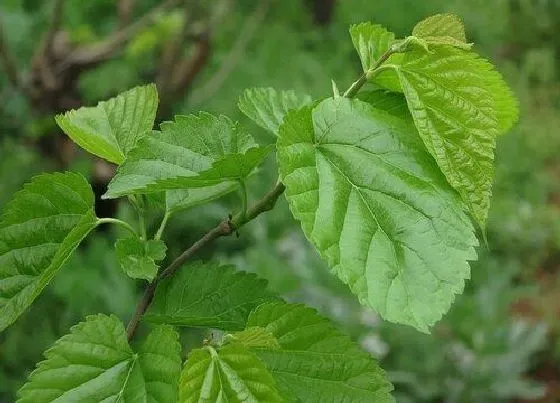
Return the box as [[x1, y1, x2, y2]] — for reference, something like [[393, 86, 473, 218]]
[[126, 182, 286, 341]]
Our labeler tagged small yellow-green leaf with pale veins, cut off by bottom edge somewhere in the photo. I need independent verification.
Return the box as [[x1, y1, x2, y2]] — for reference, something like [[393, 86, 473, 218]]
[[179, 344, 284, 403]]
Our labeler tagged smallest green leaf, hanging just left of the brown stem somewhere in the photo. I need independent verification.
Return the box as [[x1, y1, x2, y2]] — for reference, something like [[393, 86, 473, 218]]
[[115, 237, 167, 281]]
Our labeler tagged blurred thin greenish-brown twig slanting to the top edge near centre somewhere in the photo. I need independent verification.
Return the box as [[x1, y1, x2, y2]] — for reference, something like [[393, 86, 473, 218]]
[[190, 0, 272, 105]]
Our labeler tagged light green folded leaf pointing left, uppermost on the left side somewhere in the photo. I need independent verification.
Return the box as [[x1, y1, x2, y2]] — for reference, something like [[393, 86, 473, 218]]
[[55, 84, 158, 164]]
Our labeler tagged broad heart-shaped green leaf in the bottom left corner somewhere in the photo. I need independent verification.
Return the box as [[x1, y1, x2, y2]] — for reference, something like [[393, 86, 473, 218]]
[[18, 314, 181, 403]]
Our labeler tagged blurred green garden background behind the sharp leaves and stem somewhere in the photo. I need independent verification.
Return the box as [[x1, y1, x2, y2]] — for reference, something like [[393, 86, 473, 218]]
[[0, 0, 560, 402]]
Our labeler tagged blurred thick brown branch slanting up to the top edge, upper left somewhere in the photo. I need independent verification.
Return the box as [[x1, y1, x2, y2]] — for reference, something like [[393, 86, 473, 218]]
[[62, 0, 179, 68]]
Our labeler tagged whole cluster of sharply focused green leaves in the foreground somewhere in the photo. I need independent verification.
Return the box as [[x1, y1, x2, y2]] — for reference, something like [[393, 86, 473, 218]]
[[0, 15, 517, 402]]
